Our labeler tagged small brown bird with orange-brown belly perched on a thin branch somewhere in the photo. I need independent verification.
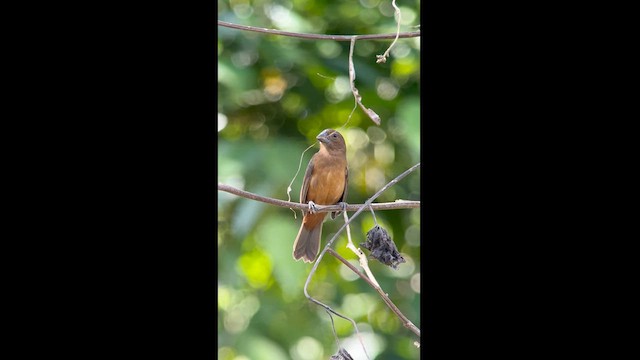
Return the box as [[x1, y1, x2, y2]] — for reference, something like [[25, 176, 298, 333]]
[[293, 129, 349, 262]]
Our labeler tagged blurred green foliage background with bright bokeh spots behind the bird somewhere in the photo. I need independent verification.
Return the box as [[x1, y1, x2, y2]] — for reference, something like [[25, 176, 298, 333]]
[[217, 0, 421, 360]]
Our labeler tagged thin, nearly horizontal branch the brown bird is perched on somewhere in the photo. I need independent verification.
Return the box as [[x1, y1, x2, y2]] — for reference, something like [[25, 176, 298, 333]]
[[218, 183, 420, 212]]
